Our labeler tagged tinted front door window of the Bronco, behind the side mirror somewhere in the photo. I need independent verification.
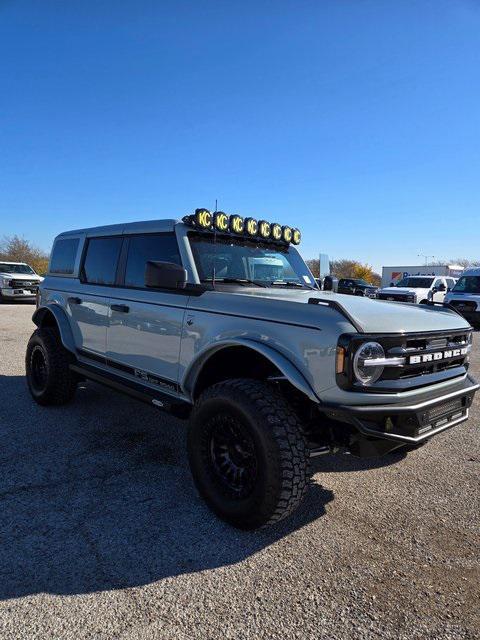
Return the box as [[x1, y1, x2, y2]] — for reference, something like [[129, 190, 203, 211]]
[[125, 233, 182, 287]]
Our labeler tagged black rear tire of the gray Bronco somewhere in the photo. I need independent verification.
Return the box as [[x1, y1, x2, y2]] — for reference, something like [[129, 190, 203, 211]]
[[25, 327, 78, 406]]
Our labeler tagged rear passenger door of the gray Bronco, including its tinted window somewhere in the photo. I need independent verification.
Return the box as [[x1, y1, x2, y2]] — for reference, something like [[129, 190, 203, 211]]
[[66, 236, 122, 359]]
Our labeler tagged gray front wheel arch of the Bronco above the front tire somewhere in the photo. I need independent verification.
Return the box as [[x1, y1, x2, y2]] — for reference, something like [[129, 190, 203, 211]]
[[182, 339, 319, 403]]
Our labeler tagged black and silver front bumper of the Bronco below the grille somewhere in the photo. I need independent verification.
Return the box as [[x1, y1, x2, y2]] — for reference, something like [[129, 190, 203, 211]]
[[327, 375, 480, 455]]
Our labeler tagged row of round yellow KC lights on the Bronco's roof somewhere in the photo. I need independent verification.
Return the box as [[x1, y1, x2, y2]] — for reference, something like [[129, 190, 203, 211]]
[[183, 209, 302, 244]]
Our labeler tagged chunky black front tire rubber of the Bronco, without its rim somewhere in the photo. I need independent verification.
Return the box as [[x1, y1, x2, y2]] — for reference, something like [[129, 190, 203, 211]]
[[188, 379, 309, 529]]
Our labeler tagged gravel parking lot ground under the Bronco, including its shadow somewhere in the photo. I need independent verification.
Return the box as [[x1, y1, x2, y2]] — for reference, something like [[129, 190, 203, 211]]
[[0, 305, 480, 640]]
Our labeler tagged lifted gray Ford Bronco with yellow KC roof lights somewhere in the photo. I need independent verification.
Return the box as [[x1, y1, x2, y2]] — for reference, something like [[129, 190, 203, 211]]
[[26, 209, 479, 529]]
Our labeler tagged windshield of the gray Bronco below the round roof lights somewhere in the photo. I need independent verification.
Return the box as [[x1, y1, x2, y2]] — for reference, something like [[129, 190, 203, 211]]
[[189, 234, 316, 288]]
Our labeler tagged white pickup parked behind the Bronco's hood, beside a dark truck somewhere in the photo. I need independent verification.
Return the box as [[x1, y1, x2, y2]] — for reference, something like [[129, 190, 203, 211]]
[[377, 276, 455, 304]]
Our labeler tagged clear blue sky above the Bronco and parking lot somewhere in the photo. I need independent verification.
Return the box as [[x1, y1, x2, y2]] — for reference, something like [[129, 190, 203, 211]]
[[0, 0, 480, 269]]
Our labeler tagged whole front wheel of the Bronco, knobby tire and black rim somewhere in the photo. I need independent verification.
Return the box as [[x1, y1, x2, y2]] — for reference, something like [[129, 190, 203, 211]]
[[188, 379, 309, 529]]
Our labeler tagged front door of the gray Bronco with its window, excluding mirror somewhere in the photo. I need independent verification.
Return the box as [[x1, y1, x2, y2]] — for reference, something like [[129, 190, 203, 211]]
[[107, 233, 188, 388]]
